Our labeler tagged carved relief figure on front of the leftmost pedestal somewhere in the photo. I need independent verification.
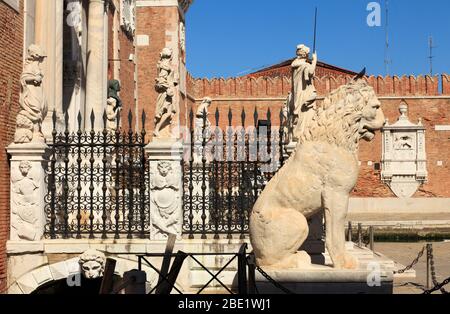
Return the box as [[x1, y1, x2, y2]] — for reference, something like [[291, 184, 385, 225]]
[[11, 161, 42, 241]]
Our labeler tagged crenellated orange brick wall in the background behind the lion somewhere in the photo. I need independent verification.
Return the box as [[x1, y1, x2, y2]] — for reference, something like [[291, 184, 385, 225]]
[[188, 75, 450, 197]]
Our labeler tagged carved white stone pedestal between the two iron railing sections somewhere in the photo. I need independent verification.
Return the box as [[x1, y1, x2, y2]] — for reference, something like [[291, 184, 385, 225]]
[[146, 140, 183, 240]]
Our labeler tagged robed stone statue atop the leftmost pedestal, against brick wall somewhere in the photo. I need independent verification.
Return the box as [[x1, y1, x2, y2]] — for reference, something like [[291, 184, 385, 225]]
[[14, 45, 47, 144]]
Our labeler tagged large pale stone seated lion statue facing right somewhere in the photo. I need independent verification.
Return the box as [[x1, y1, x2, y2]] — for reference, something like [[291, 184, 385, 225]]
[[250, 79, 385, 269]]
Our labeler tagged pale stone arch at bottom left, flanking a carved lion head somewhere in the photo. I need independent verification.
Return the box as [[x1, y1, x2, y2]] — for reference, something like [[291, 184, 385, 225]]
[[8, 257, 158, 294]]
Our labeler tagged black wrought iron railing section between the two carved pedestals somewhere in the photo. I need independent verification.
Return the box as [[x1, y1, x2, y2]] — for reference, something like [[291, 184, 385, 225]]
[[45, 111, 150, 239]]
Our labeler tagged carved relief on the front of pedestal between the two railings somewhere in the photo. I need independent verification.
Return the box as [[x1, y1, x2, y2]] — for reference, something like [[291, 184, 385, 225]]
[[150, 161, 183, 238]]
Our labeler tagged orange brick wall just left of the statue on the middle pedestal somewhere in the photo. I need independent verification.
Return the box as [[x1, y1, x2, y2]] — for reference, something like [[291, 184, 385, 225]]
[[136, 7, 179, 137]]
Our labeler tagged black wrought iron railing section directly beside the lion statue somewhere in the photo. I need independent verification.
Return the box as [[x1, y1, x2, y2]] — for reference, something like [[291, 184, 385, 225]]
[[183, 109, 284, 239]]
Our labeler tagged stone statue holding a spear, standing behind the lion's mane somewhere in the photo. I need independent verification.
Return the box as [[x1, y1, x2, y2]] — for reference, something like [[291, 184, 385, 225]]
[[291, 45, 317, 140]]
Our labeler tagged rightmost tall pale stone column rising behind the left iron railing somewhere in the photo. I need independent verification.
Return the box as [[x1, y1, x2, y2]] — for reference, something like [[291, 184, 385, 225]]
[[85, 0, 107, 131]]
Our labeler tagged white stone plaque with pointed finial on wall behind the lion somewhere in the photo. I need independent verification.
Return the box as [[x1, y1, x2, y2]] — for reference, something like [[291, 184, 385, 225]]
[[381, 102, 428, 198]]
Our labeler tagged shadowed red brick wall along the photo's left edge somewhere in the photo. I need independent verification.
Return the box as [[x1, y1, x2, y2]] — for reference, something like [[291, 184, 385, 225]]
[[0, 1, 23, 293]]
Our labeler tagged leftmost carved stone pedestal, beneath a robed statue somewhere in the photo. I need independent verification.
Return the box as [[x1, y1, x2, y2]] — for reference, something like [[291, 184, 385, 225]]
[[7, 143, 47, 241]]
